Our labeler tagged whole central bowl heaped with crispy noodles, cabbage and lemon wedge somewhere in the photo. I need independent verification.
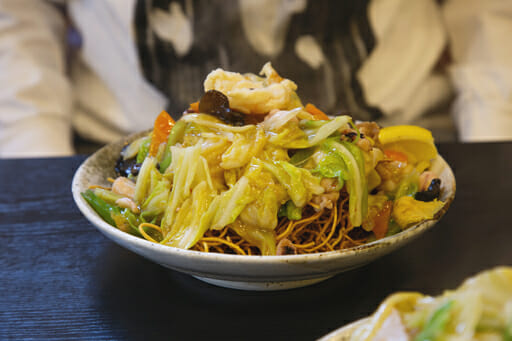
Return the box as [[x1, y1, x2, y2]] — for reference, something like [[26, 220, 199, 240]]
[[72, 63, 455, 290]]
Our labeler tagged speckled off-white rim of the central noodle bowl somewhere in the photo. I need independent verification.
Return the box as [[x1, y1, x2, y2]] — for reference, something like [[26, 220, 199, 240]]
[[71, 131, 456, 271]]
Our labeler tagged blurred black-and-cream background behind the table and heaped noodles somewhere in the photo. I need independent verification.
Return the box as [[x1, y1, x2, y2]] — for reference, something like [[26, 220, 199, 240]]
[[0, 0, 512, 158]]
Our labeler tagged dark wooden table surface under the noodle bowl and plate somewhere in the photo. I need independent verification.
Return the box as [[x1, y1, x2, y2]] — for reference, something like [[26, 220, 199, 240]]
[[0, 143, 512, 340]]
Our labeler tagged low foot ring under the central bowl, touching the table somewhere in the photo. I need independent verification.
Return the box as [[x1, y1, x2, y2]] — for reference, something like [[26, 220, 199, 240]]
[[194, 276, 332, 291]]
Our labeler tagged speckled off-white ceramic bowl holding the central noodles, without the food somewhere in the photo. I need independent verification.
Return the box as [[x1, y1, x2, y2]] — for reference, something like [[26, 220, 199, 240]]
[[72, 133, 455, 290]]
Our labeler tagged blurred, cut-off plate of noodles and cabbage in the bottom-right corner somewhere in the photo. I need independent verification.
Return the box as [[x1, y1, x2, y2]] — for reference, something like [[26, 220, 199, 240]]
[[319, 266, 512, 341]]
